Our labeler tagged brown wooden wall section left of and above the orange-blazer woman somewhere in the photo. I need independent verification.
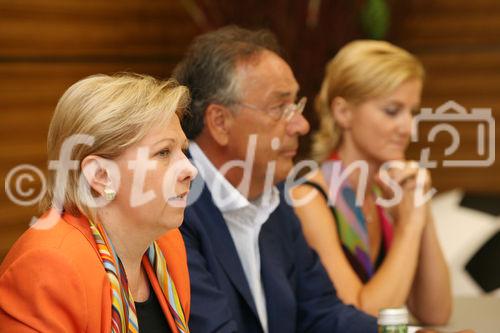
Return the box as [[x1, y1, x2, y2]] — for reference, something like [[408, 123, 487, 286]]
[[0, 0, 198, 260]]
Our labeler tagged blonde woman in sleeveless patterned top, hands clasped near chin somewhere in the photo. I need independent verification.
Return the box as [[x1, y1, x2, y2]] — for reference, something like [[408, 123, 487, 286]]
[[291, 41, 451, 325]]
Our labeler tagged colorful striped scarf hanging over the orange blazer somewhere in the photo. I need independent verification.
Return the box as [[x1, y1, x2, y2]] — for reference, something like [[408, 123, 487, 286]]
[[90, 222, 189, 333]]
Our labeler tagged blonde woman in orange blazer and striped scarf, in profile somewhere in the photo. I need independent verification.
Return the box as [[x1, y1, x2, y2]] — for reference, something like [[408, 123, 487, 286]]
[[0, 74, 196, 333]]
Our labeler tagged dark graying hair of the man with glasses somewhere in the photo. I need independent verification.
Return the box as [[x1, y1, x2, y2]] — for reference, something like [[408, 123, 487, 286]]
[[173, 26, 281, 139]]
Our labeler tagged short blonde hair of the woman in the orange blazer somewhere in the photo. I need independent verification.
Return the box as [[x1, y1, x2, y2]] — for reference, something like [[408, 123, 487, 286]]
[[41, 73, 189, 218]]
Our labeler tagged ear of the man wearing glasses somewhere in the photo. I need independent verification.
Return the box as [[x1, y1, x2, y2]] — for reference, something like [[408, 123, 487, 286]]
[[205, 104, 234, 146]]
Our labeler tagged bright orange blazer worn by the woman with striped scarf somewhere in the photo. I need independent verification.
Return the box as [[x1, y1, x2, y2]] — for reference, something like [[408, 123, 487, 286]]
[[0, 214, 190, 333]]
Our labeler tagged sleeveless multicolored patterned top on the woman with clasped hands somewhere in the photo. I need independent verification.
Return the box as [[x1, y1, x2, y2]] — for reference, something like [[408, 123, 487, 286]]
[[307, 154, 393, 283]]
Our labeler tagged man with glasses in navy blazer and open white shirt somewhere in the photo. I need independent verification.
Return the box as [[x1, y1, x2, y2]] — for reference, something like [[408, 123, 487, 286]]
[[174, 26, 376, 333]]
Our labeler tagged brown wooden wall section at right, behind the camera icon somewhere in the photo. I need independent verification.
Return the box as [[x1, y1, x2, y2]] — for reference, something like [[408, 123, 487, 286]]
[[392, 0, 500, 193]]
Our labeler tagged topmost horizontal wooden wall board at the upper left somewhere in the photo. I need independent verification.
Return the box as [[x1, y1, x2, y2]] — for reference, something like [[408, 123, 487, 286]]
[[0, 0, 197, 57]]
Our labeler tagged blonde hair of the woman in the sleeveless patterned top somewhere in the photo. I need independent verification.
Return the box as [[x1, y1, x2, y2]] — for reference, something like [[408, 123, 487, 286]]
[[312, 40, 425, 162]]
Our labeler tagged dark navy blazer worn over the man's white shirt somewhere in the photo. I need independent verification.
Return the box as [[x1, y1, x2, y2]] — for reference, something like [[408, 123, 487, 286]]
[[181, 175, 377, 333]]
